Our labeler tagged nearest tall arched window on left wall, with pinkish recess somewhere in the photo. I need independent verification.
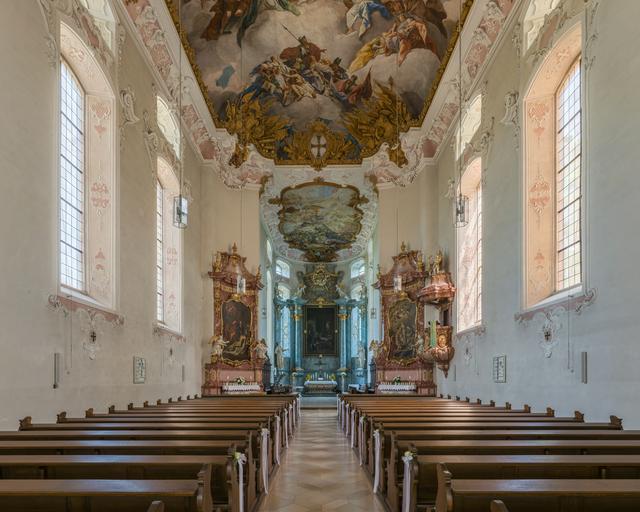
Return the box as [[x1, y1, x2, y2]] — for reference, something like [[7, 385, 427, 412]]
[[58, 23, 116, 309]]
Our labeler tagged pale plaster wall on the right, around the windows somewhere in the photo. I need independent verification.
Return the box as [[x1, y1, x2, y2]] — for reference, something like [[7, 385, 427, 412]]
[[438, 0, 640, 428]]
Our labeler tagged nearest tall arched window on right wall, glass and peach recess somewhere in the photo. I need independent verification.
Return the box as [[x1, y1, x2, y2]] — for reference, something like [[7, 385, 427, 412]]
[[524, 23, 583, 307]]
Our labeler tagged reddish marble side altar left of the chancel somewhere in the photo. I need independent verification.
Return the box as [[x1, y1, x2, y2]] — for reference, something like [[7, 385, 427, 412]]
[[202, 244, 268, 396]]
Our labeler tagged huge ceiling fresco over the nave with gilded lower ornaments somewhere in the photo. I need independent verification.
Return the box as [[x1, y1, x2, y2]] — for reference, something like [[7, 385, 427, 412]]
[[166, 0, 473, 169]]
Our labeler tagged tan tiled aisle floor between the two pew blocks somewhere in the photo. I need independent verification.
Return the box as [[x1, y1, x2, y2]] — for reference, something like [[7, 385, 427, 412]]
[[260, 408, 384, 512]]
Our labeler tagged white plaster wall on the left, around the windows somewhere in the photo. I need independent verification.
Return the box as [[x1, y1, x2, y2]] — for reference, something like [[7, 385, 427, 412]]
[[0, 0, 202, 429]]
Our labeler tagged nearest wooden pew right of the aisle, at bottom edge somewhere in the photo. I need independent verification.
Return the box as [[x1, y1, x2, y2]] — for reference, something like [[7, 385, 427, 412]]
[[435, 465, 640, 512]]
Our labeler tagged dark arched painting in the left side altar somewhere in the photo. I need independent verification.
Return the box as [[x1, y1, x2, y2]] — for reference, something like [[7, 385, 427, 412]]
[[222, 300, 251, 362]]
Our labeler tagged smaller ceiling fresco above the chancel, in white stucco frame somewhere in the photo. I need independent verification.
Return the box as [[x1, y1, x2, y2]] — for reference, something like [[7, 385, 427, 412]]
[[270, 181, 368, 262]]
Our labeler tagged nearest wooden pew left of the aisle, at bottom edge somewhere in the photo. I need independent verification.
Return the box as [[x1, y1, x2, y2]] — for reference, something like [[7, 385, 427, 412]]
[[0, 480, 210, 512]]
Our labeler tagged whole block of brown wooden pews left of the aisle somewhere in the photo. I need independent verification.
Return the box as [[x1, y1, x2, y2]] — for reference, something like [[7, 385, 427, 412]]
[[0, 395, 300, 512]]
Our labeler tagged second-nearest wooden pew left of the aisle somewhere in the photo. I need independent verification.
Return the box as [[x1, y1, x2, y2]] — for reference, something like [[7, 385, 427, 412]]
[[0, 455, 239, 511]]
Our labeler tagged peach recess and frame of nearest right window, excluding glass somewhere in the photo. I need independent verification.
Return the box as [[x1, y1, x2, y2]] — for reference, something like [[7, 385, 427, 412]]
[[519, 21, 589, 308]]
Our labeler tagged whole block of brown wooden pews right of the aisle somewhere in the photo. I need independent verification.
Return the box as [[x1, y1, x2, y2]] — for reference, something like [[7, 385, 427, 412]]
[[338, 395, 640, 512]]
